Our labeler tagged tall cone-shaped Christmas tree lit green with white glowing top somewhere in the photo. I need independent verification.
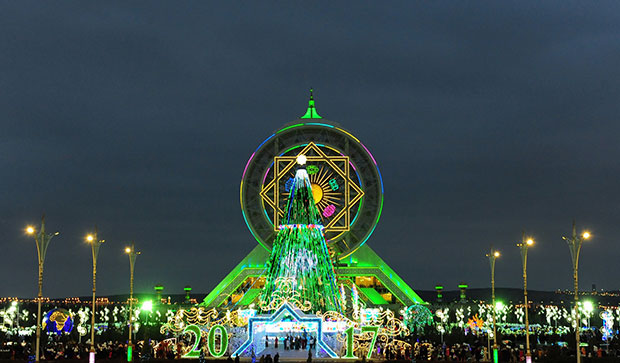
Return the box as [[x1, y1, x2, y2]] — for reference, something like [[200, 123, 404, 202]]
[[260, 155, 341, 312]]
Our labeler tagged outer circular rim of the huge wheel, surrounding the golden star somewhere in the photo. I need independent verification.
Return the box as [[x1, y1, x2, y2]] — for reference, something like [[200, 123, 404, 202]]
[[240, 119, 383, 259]]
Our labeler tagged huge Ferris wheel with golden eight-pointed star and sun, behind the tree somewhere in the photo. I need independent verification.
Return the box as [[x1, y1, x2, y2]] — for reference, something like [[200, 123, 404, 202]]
[[240, 116, 383, 260]]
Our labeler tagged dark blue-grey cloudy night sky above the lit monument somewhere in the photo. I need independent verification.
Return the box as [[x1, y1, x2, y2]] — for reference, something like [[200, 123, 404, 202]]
[[0, 1, 620, 297]]
